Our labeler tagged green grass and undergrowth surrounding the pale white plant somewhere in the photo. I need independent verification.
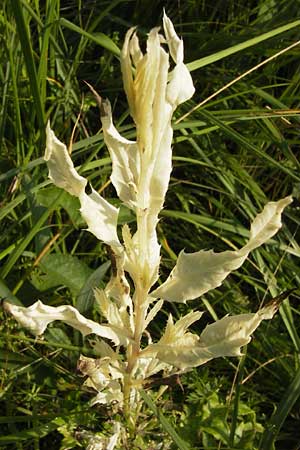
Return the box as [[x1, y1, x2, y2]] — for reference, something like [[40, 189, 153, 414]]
[[0, 0, 300, 450]]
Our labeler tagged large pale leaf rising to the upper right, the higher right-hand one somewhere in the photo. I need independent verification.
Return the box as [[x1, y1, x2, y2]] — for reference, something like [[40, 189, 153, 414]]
[[151, 197, 292, 302]]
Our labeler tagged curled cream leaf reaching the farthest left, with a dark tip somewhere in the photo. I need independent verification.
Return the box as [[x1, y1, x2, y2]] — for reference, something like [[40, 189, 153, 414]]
[[5, 300, 120, 345]]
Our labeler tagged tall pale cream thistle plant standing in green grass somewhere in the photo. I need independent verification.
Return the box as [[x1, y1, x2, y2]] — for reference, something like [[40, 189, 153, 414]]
[[6, 15, 292, 448]]
